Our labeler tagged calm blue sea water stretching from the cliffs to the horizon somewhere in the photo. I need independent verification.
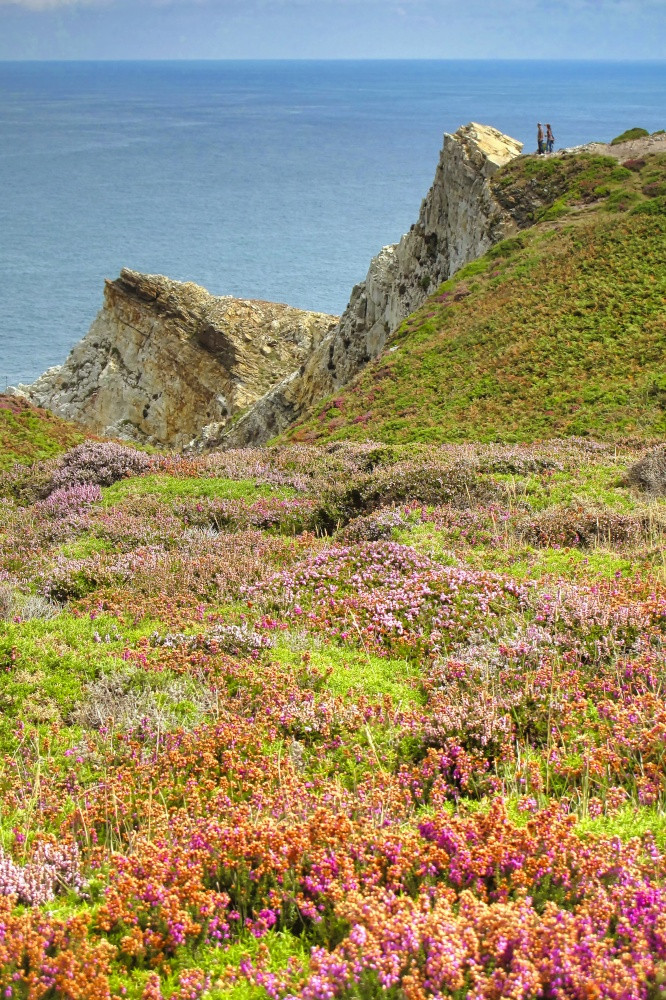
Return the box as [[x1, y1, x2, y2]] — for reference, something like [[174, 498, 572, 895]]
[[0, 61, 666, 390]]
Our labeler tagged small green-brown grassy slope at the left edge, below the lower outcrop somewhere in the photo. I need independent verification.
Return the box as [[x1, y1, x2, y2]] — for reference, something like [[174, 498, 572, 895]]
[[0, 396, 85, 469]]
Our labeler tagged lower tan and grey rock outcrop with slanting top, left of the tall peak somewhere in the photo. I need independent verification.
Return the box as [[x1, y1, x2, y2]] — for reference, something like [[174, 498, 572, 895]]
[[13, 270, 337, 448]]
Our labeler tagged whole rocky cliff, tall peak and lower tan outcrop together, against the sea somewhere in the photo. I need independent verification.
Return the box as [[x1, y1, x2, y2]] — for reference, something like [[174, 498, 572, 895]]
[[13, 122, 522, 449]]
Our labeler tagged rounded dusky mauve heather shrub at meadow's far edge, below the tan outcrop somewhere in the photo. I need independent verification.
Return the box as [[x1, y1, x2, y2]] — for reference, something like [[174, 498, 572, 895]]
[[49, 441, 153, 492]]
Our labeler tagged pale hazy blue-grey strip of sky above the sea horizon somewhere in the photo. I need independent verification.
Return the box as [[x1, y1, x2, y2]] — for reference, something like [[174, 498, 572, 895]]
[[0, 0, 666, 60]]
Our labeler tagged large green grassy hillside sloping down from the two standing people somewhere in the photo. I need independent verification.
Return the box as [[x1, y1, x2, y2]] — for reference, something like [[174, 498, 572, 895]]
[[288, 148, 666, 442]]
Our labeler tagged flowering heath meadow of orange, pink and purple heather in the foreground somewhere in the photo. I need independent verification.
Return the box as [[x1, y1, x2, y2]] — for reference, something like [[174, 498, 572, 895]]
[[0, 438, 666, 1000]]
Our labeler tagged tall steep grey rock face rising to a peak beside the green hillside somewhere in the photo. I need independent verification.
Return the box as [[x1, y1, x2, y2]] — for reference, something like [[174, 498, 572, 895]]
[[215, 122, 522, 447]]
